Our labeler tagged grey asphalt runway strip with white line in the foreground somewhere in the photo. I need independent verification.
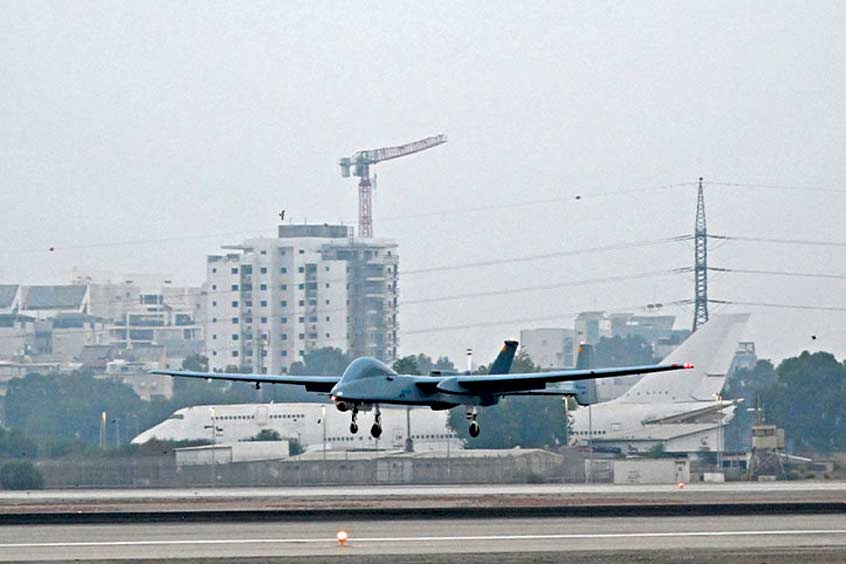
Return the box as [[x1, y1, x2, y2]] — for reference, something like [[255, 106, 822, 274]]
[[0, 512, 846, 562]]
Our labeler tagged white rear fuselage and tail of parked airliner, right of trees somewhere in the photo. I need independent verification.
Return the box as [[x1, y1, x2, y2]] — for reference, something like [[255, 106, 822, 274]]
[[570, 313, 749, 453]]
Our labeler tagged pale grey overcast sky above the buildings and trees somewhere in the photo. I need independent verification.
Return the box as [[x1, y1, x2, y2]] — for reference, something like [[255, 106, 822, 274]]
[[0, 1, 846, 361]]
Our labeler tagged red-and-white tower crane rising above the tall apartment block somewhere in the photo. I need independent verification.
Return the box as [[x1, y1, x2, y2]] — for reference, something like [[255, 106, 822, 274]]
[[339, 135, 447, 239]]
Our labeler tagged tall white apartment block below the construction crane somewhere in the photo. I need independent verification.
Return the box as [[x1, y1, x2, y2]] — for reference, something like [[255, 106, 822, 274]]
[[205, 225, 399, 373]]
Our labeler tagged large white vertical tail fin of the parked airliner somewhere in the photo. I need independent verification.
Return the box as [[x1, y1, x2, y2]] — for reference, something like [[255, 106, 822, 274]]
[[619, 313, 749, 403]]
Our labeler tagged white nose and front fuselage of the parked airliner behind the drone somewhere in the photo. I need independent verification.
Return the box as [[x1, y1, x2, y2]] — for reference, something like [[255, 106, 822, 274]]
[[132, 403, 463, 451]]
